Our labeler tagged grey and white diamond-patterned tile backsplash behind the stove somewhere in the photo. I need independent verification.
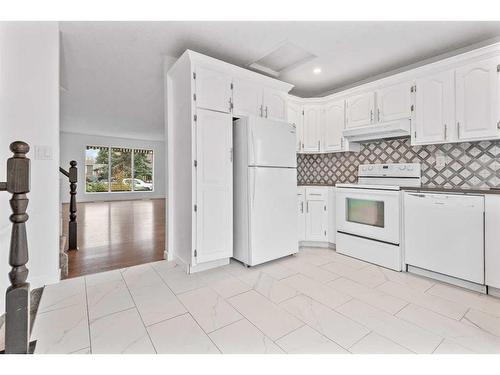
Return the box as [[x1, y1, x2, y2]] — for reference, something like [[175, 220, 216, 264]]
[[297, 138, 500, 188]]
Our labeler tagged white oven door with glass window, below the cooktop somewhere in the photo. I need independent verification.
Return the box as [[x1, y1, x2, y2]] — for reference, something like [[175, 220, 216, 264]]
[[336, 188, 400, 245]]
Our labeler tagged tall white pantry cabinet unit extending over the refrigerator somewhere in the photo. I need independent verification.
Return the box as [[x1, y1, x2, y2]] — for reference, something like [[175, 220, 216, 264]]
[[165, 50, 293, 273]]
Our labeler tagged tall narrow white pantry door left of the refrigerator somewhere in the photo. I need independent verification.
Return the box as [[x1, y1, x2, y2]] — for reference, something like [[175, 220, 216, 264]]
[[193, 109, 233, 264]]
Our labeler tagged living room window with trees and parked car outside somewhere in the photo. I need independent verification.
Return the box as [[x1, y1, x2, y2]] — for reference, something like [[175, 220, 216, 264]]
[[85, 146, 154, 193]]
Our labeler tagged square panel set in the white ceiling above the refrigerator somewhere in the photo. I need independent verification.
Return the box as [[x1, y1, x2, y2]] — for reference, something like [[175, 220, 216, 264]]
[[248, 41, 316, 77]]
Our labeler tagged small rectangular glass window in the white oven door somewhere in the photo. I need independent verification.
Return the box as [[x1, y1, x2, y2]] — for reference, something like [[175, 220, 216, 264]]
[[346, 198, 384, 228]]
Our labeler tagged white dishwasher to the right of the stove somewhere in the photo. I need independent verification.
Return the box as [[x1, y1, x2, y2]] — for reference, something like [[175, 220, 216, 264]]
[[403, 192, 484, 284]]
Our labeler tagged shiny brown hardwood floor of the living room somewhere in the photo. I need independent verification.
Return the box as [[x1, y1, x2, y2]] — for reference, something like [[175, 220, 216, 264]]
[[63, 199, 165, 278]]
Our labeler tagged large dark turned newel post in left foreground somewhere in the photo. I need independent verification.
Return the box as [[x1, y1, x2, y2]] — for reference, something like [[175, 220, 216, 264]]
[[2, 141, 30, 354]]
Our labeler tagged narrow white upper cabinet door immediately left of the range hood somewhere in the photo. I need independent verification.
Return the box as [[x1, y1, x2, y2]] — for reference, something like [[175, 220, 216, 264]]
[[323, 100, 345, 152]]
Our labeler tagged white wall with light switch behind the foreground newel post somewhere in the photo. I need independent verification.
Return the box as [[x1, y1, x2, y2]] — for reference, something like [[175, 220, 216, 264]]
[[0, 22, 59, 312]]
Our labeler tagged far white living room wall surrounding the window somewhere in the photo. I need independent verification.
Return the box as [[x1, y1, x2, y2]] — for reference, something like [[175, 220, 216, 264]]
[[60, 132, 166, 203]]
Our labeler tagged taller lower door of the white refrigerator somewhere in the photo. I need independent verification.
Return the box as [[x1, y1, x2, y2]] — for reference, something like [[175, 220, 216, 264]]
[[248, 167, 298, 266]]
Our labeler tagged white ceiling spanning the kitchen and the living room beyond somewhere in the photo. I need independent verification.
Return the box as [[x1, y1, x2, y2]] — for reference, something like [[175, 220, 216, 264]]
[[60, 21, 500, 139]]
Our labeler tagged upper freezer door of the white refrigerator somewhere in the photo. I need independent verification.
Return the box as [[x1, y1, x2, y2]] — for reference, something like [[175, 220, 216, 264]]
[[248, 117, 297, 168]]
